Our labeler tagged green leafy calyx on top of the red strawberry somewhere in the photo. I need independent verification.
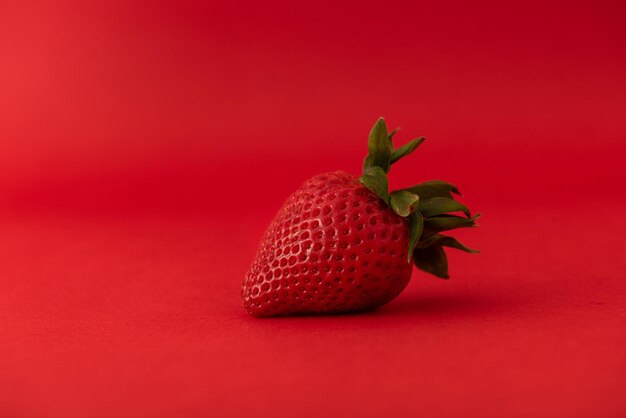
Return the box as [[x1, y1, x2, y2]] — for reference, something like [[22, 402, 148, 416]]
[[360, 118, 480, 279]]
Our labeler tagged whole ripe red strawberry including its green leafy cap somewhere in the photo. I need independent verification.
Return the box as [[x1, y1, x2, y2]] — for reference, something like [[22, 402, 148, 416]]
[[242, 118, 479, 317]]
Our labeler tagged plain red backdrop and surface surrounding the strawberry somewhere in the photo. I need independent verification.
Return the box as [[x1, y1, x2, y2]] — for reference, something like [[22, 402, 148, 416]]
[[0, 1, 626, 417]]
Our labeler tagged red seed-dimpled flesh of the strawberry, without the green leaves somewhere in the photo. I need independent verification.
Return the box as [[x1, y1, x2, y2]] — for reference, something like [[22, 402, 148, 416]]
[[242, 172, 412, 316]]
